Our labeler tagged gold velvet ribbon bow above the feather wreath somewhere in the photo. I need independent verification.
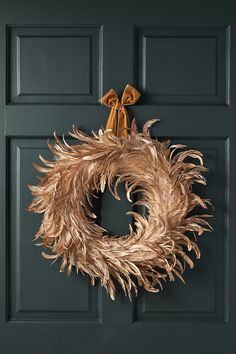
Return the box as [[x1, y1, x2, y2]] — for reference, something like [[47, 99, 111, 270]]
[[100, 84, 140, 137]]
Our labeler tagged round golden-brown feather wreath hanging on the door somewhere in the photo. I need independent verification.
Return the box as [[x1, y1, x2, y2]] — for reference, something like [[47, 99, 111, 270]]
[[28, 84, 211, 299]]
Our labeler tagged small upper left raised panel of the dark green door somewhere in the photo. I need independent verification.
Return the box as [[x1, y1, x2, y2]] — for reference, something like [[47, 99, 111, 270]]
[[7, 26, 103, 104]]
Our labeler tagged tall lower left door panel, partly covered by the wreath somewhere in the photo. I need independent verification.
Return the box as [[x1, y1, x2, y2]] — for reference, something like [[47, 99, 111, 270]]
[[7, 138, 101, 323]]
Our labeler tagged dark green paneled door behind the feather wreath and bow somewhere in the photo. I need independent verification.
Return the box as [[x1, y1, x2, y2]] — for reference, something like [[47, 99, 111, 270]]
[[0, 0, 236, 354]]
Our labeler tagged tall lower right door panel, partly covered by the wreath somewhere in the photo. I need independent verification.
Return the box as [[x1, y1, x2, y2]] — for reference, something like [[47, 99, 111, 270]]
[[133, 138, 229, 322]]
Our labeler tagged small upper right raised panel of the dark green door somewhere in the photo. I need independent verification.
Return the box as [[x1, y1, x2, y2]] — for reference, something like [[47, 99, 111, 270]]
[[134, 27, 230, 105]]
